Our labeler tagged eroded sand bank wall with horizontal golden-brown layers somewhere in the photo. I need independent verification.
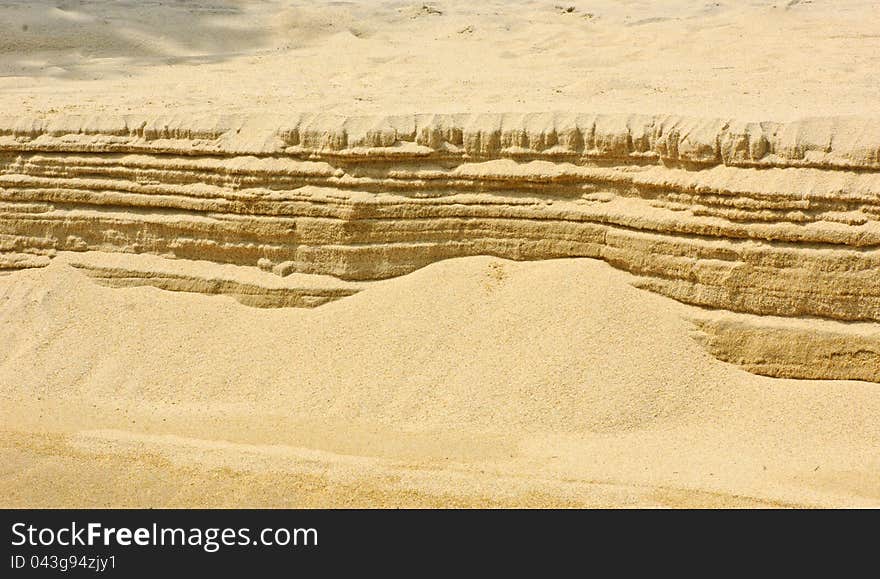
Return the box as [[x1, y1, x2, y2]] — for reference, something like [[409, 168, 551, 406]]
[[0, 114, 880, 381]]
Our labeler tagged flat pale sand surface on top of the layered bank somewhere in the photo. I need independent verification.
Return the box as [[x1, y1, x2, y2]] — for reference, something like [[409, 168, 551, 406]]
[[0, 0, 880, 121]]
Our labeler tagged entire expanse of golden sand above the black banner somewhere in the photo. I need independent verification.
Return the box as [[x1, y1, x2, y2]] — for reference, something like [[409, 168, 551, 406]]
[[0, 2, 880, 507]]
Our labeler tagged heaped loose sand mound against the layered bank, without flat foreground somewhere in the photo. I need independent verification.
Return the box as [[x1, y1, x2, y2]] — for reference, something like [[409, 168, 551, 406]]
[[0, 258, 739, 432]]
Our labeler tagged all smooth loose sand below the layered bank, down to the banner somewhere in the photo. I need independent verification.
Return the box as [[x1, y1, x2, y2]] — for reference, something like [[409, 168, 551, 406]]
[[0, 257, 880, 506]]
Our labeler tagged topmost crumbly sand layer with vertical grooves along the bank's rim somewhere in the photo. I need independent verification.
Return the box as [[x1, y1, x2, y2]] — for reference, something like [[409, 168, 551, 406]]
[[0, 113, 880, 169]]
